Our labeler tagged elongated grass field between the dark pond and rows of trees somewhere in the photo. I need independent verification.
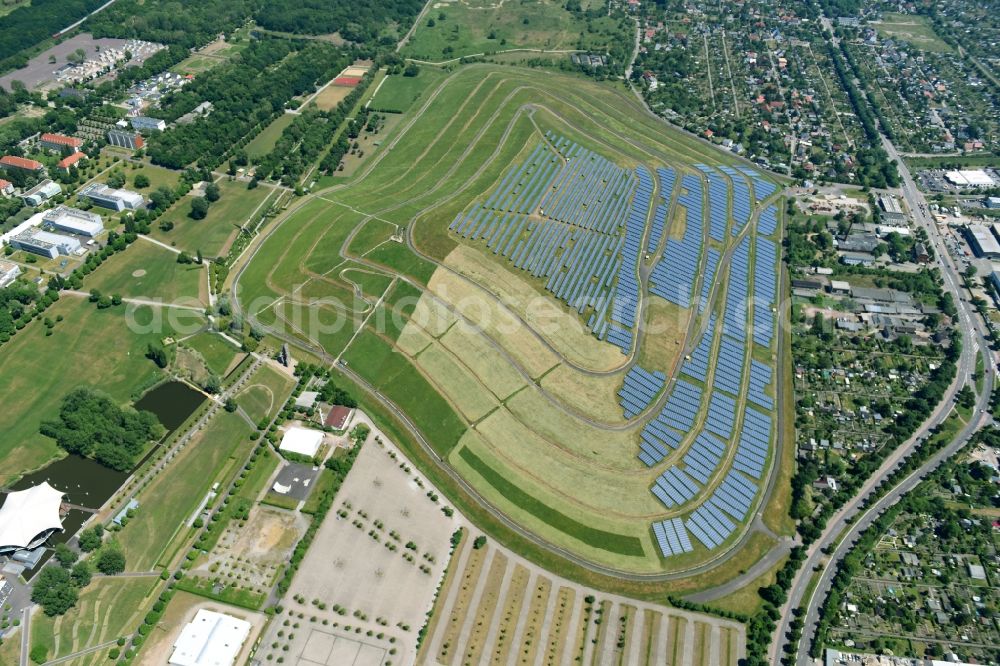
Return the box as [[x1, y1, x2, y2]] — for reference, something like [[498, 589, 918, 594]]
[[118, 411, 252, 571]]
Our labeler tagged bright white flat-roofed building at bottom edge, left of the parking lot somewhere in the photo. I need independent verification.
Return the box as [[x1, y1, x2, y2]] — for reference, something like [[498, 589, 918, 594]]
[[167, 608, 253, 666]]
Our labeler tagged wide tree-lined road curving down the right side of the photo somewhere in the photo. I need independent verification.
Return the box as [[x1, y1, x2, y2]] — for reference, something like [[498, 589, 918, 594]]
[[770, 137, 995, 666]]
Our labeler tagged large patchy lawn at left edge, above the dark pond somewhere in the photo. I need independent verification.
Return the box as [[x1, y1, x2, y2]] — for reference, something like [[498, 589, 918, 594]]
[[0, 296, 204, 484]]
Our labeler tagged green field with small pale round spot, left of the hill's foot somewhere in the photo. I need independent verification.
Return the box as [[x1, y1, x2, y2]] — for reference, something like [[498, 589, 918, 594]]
[[87, 240, 208, 306]]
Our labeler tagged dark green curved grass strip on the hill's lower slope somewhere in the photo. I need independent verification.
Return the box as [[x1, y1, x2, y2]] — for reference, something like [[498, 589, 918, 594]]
[[458, 448, 643, 557]]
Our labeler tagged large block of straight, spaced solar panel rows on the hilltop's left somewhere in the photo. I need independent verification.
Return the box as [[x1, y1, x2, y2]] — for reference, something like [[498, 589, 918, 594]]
[[449, 132, 656, 353]]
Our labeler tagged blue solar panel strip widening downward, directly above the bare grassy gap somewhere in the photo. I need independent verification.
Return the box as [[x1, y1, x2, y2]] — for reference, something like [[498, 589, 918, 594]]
[[649, 174, 704, 308]]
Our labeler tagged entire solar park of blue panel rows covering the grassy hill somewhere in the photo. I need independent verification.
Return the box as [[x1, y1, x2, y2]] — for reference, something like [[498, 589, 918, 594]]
[[449, 126, 779, 558]]
